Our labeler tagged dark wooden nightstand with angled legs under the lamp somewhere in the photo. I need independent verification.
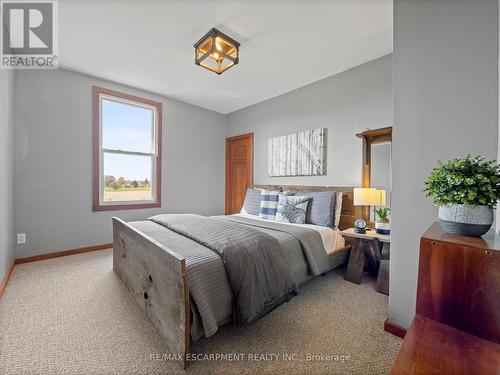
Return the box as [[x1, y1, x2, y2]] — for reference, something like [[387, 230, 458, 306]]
[[340, 228, 391, 294]]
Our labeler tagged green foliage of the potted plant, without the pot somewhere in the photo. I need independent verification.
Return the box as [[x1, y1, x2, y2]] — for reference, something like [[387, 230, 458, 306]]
[[424, 155, 500, 208]]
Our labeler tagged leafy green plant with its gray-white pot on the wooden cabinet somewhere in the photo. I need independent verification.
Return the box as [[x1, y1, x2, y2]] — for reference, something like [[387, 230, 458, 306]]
[[424, 155, 500, 237]]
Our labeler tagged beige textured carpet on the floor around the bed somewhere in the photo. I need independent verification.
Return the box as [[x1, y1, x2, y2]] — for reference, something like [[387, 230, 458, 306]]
[[0, 250, 401, 374]]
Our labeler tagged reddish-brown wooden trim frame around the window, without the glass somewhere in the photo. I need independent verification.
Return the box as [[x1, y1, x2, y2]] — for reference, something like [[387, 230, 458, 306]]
[[92, 86, 163, 211]]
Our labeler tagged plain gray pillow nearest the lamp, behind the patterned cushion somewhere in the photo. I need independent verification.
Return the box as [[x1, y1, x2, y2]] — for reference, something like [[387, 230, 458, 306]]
[[295, 191, 336, 228]]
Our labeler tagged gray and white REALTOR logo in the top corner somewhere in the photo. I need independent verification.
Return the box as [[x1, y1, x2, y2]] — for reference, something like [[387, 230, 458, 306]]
[[0, 0, 58, 69]]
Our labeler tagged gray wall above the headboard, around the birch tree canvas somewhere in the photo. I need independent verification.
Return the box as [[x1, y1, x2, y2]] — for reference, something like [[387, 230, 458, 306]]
[[226, 55, 392, 186]]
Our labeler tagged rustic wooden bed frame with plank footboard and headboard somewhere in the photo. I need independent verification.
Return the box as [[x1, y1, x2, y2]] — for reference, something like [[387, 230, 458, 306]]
[[113, 185, 361, 369]]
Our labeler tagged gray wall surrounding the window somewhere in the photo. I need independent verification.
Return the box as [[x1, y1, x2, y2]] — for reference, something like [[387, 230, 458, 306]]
[[13, 70, 225, 257]]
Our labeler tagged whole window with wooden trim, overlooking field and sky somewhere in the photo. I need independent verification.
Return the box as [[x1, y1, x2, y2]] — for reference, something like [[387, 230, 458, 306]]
[[93, 86, 162, 211]]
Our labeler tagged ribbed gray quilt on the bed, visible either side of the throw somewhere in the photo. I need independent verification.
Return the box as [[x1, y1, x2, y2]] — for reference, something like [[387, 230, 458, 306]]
[[129, 215, 329, 341]]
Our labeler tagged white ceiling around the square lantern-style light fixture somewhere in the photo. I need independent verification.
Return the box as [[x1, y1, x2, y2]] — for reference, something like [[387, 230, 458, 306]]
[[59, 0, 392, 113]]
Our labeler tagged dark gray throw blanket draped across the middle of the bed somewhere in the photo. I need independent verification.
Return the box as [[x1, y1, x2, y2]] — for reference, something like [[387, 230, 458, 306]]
[[150, 214, 298, 324]]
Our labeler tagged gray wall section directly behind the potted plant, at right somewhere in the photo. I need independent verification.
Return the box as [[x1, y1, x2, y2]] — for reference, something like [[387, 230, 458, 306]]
[[389, 0, 498, 326]]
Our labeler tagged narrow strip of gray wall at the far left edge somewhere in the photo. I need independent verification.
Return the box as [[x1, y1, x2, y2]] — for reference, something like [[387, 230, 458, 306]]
[[0, 70, 14, 281]]
